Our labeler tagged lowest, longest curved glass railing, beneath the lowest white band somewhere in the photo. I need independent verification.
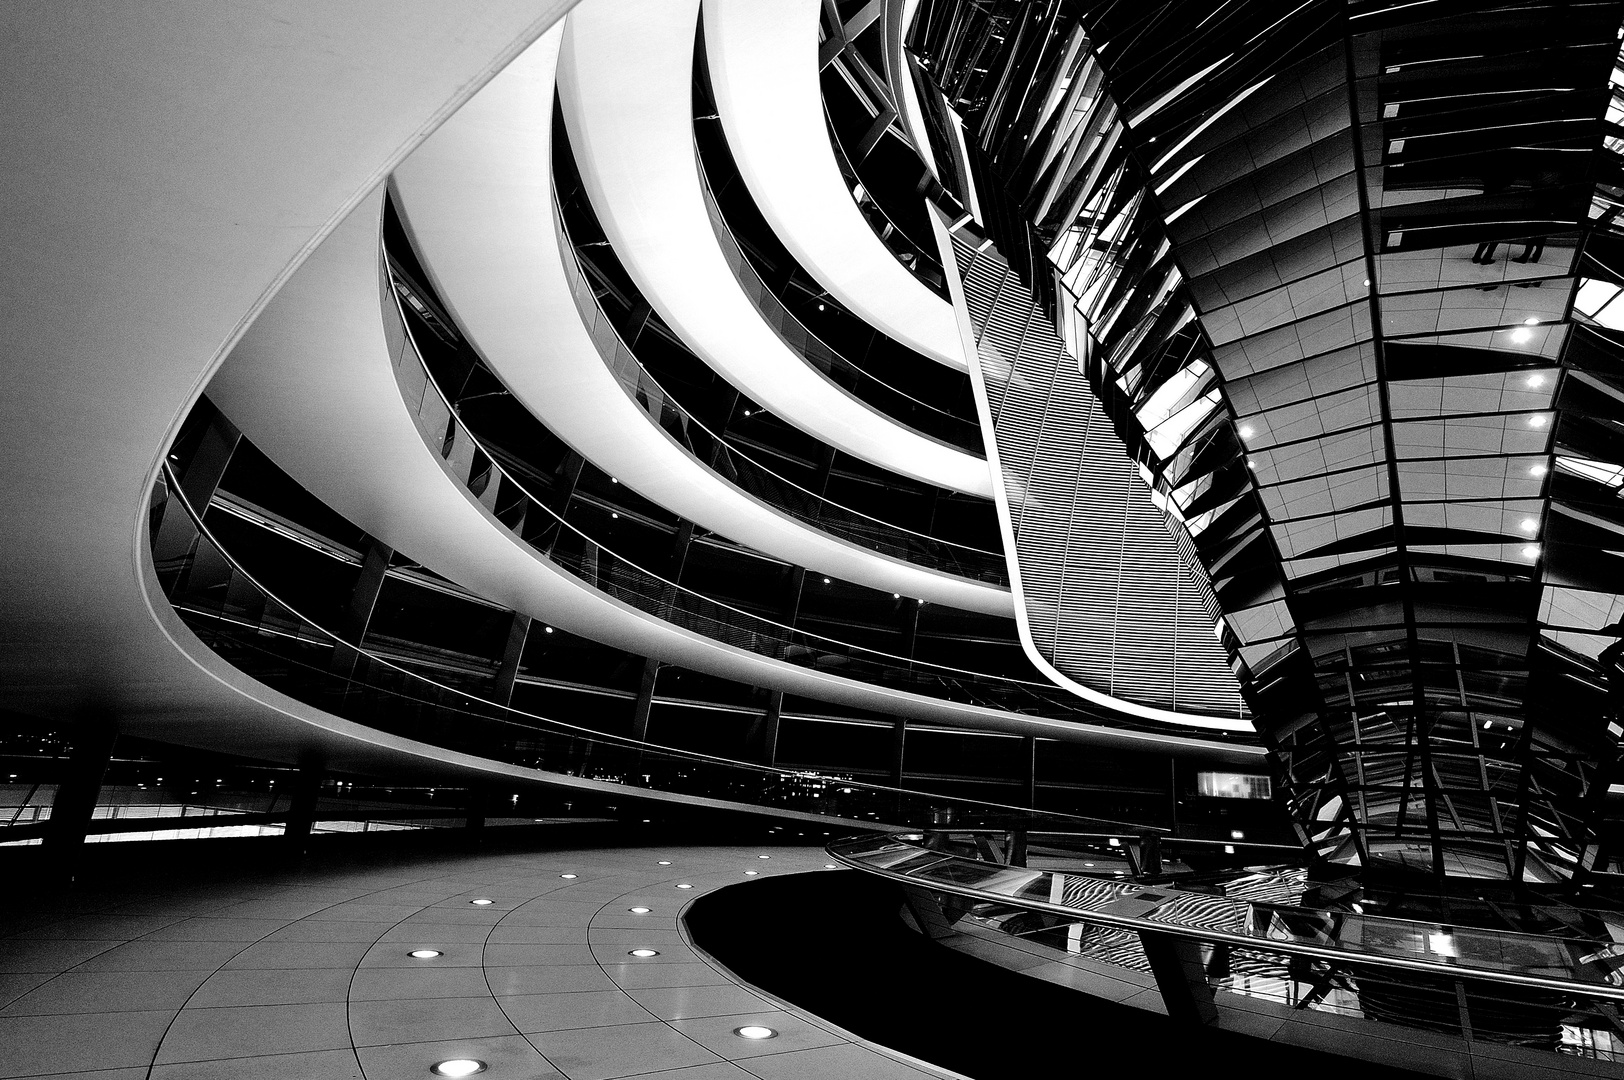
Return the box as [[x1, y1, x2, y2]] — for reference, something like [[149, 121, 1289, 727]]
[[149, 463, 1117, 825]]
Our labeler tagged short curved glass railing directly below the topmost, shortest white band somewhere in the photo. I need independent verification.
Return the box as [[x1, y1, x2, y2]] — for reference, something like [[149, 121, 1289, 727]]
[[700, 161, 983, 453]]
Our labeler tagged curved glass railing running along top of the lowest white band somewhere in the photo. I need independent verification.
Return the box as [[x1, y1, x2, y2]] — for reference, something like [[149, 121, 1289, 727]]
[[385, 277, 1149, 721]]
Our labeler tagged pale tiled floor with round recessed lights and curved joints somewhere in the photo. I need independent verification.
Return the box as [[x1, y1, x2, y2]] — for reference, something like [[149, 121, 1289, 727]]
[[0, 846, 955, 1080]]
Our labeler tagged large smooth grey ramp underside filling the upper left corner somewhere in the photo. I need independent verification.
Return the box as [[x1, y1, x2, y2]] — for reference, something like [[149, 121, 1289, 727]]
[[0, 0, 568, 771]]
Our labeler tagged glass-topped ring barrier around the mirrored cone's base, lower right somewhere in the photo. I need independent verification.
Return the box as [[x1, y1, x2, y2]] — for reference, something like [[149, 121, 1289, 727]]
[[828, 833, 1624, 1075]]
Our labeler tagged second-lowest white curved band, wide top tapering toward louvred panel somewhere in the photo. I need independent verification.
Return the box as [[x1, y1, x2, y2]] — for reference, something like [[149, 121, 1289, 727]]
[[393, 27, 1015, 617]]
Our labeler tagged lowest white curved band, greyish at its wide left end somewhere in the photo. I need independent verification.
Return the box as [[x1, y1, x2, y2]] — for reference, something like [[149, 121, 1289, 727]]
[[209, 188, 1260, 755]]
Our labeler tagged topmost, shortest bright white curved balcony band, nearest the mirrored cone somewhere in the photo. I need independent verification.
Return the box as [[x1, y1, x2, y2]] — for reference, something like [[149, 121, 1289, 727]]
[[708, 0, 970, 370]]
